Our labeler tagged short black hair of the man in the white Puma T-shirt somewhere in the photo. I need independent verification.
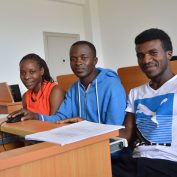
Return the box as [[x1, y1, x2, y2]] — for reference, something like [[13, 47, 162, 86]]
[[135, 28, 173, 51]]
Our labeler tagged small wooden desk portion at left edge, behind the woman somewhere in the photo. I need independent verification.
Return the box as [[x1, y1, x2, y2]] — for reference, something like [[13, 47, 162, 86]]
[[0, 102, 22, 114]]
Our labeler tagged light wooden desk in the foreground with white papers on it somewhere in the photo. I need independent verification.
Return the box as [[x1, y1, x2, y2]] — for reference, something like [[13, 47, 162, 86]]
[[0, 120, 118, 177]]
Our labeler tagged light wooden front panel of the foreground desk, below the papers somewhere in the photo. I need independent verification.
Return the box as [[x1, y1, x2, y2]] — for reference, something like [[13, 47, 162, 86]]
[[0, 141, 112, 177]]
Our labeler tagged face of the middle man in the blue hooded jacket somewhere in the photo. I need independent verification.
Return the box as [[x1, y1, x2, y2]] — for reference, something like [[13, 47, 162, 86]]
[[70, 44, 97, 79]]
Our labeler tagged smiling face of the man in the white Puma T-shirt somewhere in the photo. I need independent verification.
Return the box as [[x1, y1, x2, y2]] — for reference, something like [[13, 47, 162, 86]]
[[136, 39, 172, 79]]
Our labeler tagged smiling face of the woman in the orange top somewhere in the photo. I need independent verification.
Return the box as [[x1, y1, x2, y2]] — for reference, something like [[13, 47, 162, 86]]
[[20, 59, 44, 92]]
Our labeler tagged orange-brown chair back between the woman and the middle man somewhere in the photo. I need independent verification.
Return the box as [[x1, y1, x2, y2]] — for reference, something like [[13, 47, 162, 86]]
[[57, 74, 78, 92]]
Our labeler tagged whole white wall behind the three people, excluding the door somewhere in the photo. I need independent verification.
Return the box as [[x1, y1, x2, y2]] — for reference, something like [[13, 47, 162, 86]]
[[0, 0, 177, 92]]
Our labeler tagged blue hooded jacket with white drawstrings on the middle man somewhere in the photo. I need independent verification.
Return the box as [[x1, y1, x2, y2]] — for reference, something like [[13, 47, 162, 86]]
[[39, 68, 126, 125]]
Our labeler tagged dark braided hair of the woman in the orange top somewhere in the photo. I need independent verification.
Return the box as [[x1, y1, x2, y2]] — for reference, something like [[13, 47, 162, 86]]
[[20, 53, 54, 82]]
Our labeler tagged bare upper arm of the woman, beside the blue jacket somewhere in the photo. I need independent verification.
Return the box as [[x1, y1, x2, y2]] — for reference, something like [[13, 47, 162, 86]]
[[49, 85, 65, 115]]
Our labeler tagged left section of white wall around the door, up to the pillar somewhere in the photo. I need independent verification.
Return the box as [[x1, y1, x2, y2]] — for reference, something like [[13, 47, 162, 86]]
[[0, 0, 103, 92]]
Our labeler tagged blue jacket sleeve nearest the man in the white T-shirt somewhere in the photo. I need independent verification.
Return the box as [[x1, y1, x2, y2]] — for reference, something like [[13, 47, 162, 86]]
[[105, 78, 126, 125]]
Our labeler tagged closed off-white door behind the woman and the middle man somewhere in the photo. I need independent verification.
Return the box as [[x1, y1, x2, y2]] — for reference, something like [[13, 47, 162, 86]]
[[44, 32, 80, 81]]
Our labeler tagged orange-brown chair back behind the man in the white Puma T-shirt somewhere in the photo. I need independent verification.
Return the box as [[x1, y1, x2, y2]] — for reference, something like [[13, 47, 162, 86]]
[[117, 60, 177, 95]]
